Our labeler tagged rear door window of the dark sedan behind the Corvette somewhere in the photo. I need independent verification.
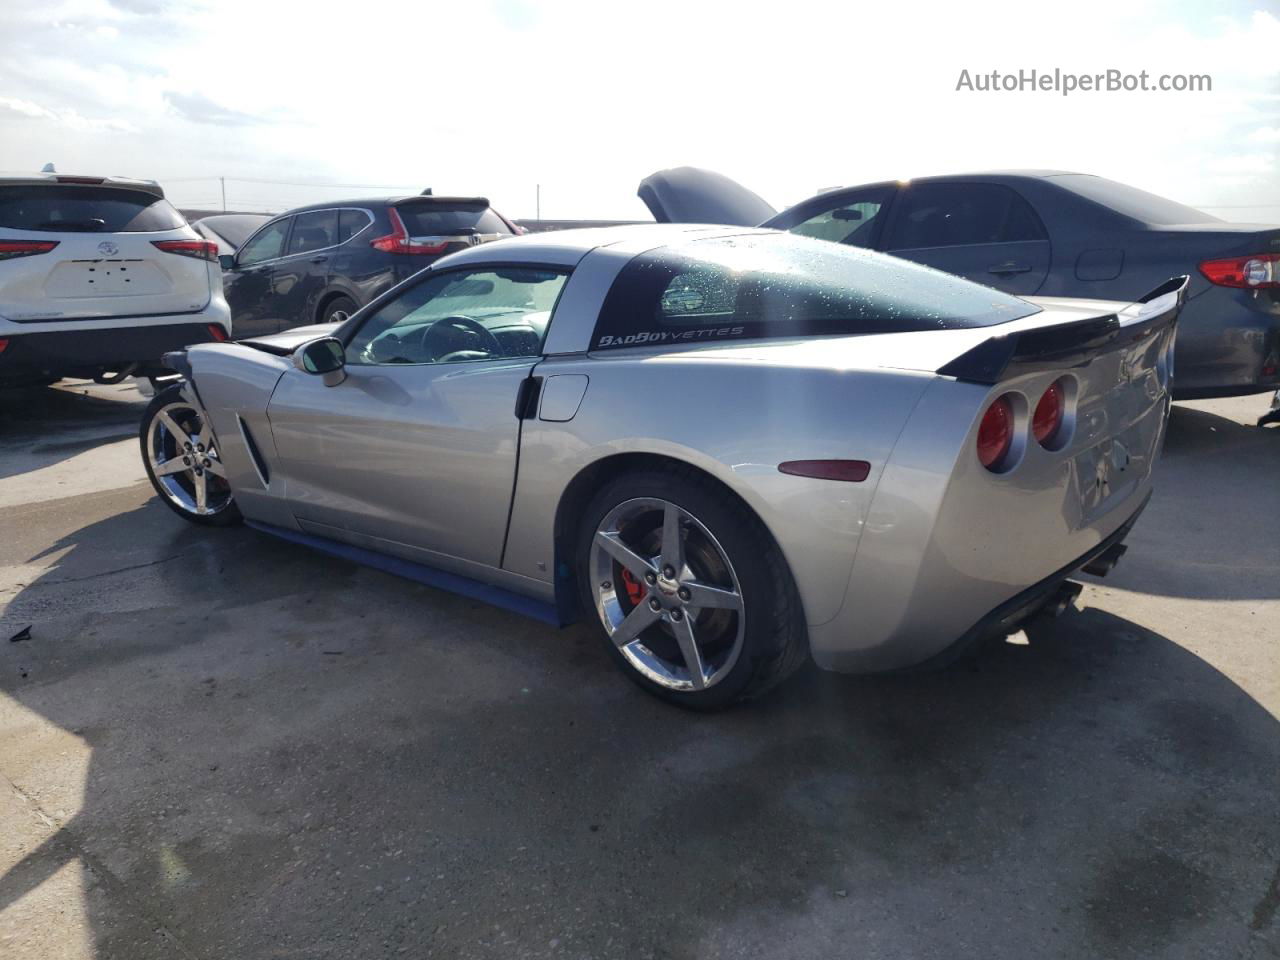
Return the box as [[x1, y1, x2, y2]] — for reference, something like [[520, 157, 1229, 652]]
[[884, 183, 1047, 250]]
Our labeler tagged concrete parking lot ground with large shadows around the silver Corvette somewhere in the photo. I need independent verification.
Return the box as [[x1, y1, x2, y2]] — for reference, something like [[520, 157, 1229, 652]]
[[0, 384, 1280, 960]]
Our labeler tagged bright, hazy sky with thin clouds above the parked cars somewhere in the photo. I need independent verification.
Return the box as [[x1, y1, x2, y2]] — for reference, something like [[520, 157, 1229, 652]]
[[0, 0, 1280, 221]]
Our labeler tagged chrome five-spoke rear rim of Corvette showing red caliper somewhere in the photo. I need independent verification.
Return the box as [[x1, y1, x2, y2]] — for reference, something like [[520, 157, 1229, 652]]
[[590, 498, 746, 691]]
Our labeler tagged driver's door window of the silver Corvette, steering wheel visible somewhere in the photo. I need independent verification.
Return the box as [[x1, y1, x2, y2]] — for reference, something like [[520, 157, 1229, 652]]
[[347, 266, 568, 365]]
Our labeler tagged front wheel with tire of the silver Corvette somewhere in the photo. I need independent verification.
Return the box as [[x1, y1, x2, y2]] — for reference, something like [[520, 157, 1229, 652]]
[[138, 384, 241, 526]]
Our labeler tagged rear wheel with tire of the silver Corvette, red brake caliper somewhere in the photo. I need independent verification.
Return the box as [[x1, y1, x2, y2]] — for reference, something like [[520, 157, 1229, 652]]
[[577, 468, 808, 709]]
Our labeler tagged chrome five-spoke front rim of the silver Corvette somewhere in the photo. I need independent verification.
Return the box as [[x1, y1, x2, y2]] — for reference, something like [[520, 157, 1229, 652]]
[[147, 401, 232, 516]]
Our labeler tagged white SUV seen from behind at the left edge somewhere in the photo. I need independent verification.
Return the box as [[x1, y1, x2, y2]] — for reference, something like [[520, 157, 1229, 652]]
[[0, 173, 232, 387]]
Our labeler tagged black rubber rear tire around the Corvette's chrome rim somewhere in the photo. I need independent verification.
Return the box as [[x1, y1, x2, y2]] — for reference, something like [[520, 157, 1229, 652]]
[[573, 465, 809, 710]]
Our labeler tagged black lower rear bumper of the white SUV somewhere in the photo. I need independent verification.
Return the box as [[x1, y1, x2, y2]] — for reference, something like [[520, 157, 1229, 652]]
[[0, 317, 225, 384]]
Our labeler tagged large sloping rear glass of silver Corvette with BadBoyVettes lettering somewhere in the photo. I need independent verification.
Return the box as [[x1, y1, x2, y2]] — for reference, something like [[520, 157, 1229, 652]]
[[591, 234, 1039, 349]]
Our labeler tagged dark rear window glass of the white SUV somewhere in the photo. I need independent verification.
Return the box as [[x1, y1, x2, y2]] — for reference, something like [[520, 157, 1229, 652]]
[[0, 186, 187, 233]]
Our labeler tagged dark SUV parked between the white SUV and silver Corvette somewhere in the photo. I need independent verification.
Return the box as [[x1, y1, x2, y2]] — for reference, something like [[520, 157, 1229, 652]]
[[219, 196, 522, 338]]
